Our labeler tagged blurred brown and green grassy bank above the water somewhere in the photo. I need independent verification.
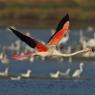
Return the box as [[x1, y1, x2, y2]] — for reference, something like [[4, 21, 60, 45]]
[[0, 0, 95, 28]]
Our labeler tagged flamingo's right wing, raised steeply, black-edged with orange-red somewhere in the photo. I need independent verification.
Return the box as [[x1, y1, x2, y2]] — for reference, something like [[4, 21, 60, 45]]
[[48, 14, 69, 46]]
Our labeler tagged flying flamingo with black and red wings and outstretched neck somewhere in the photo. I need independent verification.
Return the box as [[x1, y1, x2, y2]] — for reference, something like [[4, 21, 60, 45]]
[[9, 14, 94, 59]]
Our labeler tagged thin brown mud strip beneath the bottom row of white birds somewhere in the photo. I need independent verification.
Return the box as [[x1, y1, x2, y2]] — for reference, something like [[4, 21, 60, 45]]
[[0, 76, 95, 80]]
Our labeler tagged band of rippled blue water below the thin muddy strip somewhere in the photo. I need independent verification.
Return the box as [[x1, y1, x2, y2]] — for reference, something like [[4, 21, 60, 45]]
[[0, 80, 95, 95]]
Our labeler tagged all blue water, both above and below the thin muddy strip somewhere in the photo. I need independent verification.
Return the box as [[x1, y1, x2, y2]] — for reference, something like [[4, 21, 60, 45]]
[[0, 29, 95, 95]]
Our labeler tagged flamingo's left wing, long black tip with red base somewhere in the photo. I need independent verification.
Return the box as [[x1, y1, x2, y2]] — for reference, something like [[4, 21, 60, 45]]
[[9, 27, 48, 52]]
